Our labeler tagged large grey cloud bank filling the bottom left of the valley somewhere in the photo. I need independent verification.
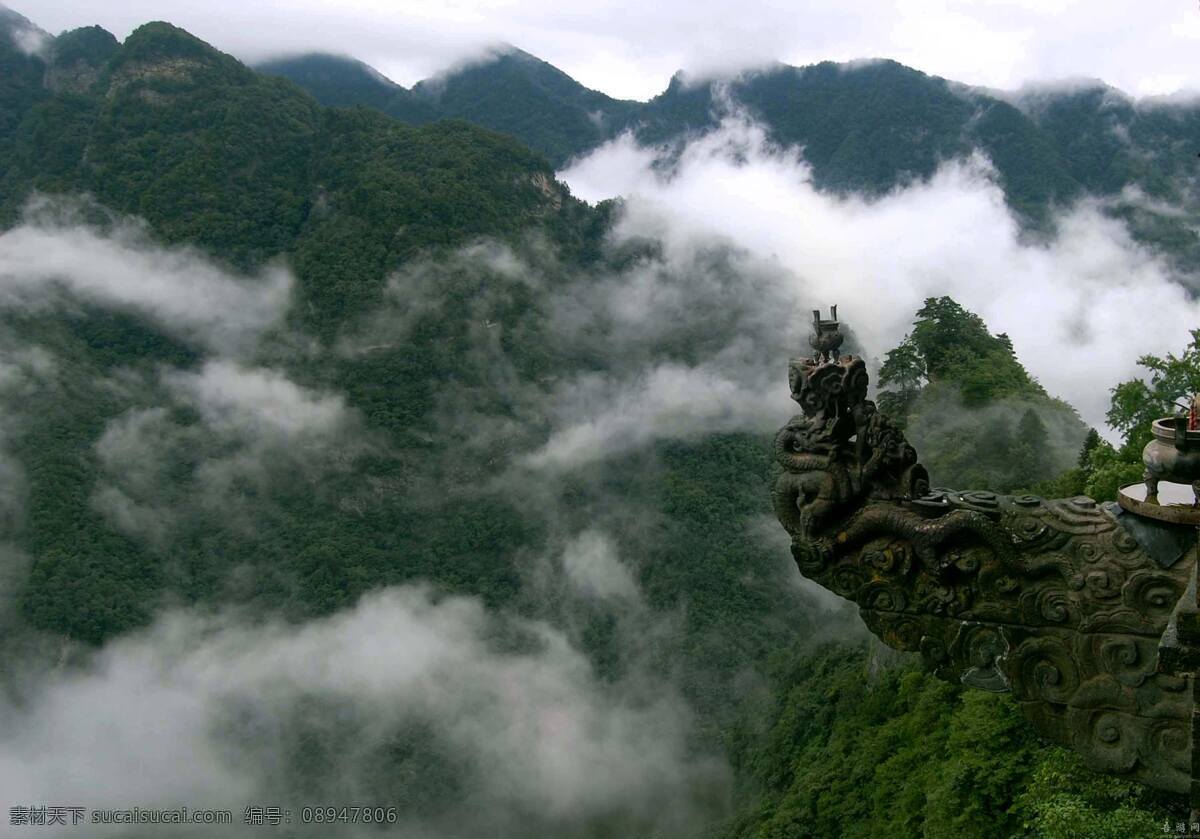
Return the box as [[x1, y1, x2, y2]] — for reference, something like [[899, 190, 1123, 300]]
[[0, 588, 726, 837]]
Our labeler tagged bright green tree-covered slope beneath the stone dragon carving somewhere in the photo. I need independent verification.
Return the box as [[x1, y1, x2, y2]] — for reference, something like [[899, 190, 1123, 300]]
[[730, 645, 1186, 839]]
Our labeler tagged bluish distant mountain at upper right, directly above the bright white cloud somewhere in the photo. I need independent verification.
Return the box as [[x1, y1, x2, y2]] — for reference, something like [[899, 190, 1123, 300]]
[[657, 60, 1200, 265]]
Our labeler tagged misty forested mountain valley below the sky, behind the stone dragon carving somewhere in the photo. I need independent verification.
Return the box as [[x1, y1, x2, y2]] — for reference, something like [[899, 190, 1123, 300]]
[[0, 4, 1200, 837]]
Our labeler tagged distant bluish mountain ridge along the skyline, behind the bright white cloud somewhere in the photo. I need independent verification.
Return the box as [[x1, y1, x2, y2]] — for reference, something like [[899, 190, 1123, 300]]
[[258, 49, 1200, 260]]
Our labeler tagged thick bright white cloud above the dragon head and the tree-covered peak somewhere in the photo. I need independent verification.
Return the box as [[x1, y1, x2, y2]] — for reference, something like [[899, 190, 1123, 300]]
[[562, 118, 1200, 439]]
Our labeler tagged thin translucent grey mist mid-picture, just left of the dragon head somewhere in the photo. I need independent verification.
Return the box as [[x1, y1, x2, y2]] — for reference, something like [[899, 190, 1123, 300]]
[[362, 169, 824, 473]]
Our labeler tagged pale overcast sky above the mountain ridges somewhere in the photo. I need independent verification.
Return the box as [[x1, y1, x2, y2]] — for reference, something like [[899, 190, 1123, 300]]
[[14, 0, 1200, 98]]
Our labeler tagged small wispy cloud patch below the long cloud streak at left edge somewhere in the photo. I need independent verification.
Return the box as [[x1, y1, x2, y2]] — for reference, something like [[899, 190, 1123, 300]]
[[92, 361, 362, 545]]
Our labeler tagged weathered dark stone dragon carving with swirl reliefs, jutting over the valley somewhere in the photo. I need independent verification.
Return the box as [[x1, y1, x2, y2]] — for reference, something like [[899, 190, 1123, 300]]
[[774, 314, 1194, 792]]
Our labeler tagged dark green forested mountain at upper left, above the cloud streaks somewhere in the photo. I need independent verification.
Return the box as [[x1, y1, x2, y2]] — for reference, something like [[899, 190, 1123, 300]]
[[0, 23, 582, 323]]
